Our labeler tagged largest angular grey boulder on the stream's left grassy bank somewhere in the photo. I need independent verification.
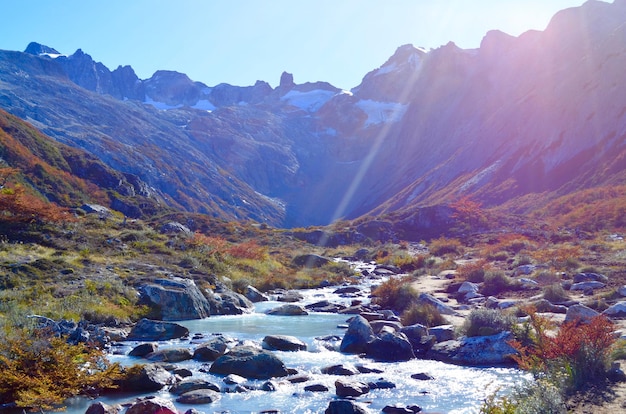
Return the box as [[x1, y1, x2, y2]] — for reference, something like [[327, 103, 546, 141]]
[[137, 277, 211, 321]]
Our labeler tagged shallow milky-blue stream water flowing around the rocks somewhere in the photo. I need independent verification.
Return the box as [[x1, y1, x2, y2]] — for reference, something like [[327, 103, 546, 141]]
[[44, 264, 527, 414]]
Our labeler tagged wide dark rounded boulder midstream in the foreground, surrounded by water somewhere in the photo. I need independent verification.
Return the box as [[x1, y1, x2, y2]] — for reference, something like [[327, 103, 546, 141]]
[[209, 345, 289, 379]]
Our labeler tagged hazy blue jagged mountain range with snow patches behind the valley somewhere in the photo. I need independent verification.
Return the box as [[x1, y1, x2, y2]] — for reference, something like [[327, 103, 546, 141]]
[[0, 0, 626, 233]]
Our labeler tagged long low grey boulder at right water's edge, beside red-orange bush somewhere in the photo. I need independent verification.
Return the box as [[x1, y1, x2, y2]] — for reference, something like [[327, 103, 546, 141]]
[[428, 332, 517, 366]]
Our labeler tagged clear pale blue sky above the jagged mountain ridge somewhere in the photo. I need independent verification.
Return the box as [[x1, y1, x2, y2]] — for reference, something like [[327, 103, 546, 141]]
[[0, 0, 584, 89]]
